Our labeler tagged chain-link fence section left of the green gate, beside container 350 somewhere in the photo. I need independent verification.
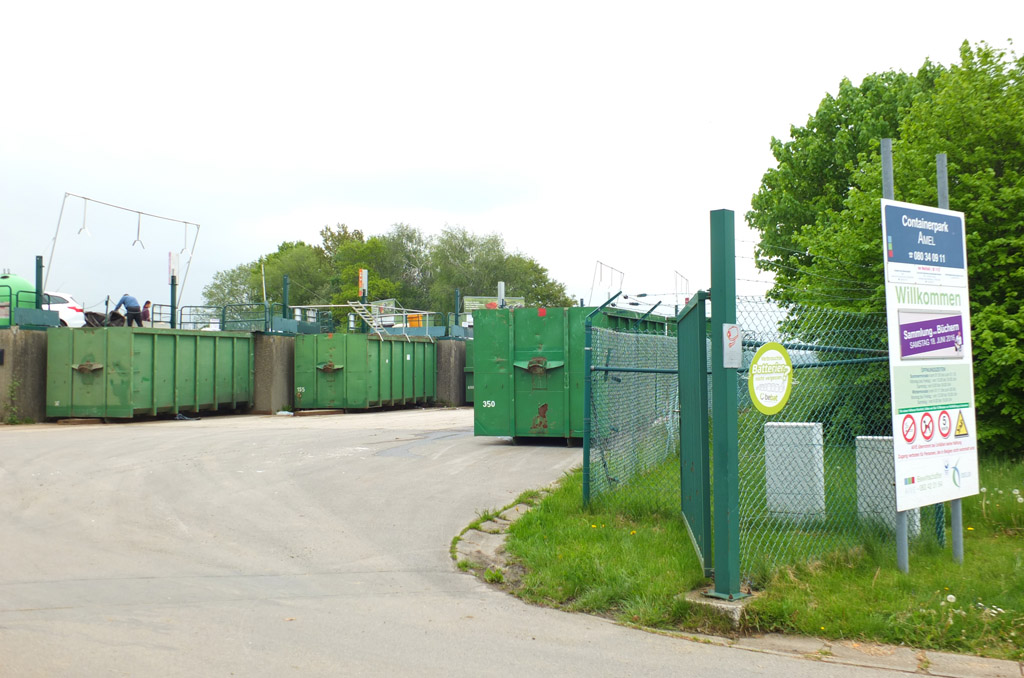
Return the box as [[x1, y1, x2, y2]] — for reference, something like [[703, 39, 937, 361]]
[[586, 328, 679, 513]]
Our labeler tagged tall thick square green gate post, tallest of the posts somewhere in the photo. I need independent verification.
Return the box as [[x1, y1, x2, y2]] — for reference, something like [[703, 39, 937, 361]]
[[709, 210, 744, 600]]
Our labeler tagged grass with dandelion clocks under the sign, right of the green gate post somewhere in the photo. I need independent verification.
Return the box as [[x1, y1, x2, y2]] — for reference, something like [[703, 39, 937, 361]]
[[748, 461, 1024, 661]]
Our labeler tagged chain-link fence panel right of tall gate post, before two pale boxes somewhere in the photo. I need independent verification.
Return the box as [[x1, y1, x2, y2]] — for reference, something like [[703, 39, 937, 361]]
[[736, 298, 905, 581]]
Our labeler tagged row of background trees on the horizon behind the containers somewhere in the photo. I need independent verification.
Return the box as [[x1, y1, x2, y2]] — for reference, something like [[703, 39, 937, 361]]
[[203, 223, 572, 312]]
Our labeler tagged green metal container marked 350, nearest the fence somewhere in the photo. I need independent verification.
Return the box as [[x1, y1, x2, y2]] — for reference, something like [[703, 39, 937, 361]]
[[467, 306, 667, 438]]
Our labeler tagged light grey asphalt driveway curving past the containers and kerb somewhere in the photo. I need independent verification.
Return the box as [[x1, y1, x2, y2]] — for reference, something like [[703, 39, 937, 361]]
[[0, 410, 909, 678]]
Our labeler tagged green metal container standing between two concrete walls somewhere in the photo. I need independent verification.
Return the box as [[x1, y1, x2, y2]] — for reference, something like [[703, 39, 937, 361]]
[[295, 333, 437, 410]]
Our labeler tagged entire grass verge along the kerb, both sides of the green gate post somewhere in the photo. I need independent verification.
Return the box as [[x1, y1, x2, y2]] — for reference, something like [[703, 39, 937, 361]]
[[507, 460, 1024, 661]]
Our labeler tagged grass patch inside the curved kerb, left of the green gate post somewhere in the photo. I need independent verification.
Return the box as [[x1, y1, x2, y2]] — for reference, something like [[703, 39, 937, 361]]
[[506, 471, 728, 632]]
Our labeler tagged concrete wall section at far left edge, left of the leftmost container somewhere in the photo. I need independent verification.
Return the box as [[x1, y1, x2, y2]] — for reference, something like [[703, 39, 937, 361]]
[[0, 327, 46, 422]]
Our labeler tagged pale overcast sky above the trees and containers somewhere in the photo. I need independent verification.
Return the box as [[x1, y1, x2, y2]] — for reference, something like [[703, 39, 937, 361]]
[[0, 0, 1024, 310]]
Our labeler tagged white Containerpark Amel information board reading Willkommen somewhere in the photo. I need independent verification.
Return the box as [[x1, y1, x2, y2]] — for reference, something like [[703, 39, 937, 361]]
[[882, 200, 978, 511]]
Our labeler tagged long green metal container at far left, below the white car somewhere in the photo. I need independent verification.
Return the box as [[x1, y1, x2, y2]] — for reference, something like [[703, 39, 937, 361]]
[[46, 327, 254, 419]]
